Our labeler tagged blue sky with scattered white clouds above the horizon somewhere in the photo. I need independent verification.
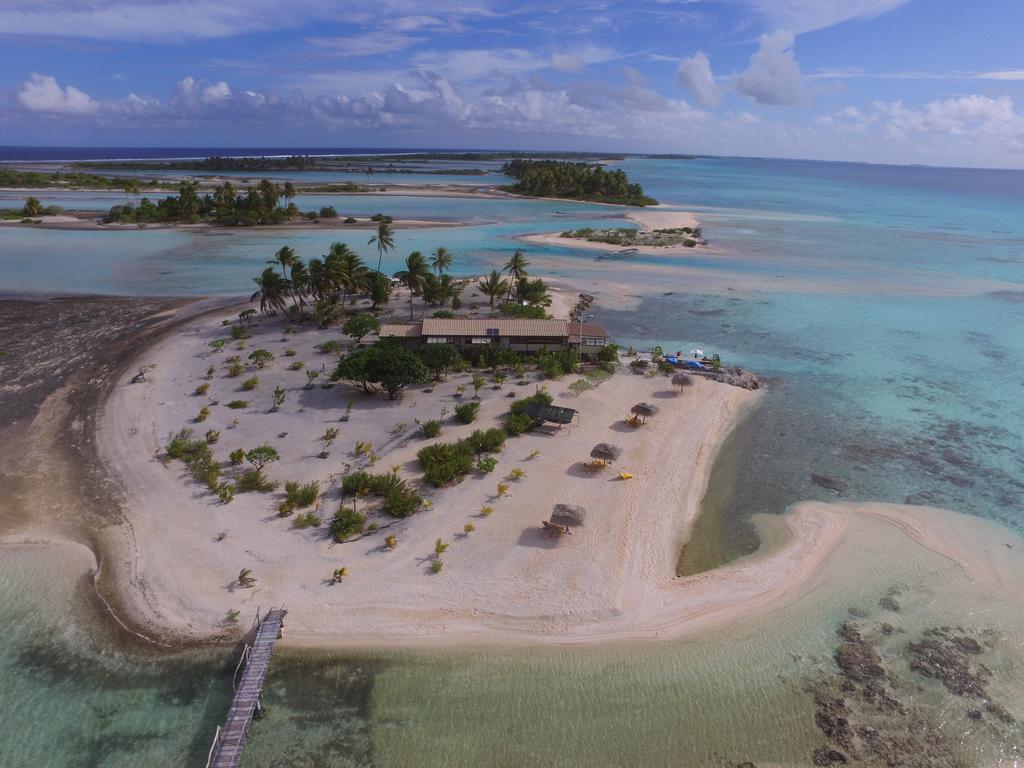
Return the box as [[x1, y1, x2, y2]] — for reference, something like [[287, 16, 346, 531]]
[[0, 0, 1024, 168]]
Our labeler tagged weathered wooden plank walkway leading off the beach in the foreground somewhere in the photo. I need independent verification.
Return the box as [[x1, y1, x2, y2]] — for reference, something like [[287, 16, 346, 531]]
[[207, 608, 288, 768]]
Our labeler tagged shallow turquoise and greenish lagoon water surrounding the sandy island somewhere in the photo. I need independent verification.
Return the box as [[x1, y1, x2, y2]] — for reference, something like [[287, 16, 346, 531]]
[[0, 154, 1024, 766]]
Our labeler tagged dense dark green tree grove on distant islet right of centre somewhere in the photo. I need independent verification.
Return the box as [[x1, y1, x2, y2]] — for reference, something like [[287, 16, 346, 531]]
[[502, 159, 657, 206]]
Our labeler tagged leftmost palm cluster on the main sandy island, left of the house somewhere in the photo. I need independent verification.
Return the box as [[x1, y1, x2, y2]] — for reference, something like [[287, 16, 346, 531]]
[[250, 243, 377, 325]]
